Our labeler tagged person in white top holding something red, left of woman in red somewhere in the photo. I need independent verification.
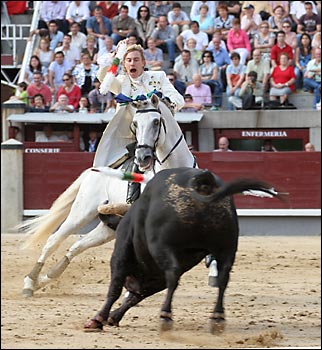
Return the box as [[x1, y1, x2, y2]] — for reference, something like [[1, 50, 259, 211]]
[[226, 52, 246, 110]]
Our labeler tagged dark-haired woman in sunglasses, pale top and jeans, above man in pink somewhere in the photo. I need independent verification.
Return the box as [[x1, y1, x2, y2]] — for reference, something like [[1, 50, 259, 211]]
[[199, 50, 223, 107]]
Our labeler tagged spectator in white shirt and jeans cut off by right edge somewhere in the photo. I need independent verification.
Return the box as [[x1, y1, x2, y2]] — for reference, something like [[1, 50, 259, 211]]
[[303, 49, 321, 109]]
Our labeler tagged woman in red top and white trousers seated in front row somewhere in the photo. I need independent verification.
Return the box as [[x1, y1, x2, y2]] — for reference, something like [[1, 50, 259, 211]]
[[269, 52, 296, 106]]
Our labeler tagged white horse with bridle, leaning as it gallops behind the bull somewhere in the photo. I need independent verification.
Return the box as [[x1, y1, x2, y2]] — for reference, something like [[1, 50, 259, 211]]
[[20, 95, 196, 297]]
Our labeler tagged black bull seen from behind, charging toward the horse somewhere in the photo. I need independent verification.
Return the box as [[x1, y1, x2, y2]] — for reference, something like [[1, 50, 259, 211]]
[[85, 168, 280, 333]]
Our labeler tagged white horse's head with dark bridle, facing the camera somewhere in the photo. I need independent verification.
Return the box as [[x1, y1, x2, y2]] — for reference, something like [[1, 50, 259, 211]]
[[132, 94, 164, 171]]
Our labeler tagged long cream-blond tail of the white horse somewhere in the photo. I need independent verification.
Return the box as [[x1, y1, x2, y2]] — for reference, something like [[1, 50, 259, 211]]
[[16, 169, 90, 249]]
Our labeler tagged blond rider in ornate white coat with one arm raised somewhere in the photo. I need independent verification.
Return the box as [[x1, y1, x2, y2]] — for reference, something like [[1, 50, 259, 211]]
[[93, 39, 184, 204]]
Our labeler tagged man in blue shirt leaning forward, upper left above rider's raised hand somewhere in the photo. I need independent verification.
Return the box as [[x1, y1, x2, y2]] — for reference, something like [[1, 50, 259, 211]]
[[86, 6, 112, 47]]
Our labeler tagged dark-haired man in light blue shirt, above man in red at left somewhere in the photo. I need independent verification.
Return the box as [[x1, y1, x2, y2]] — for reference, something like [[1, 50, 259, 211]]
[[48, 51, 72, 95]]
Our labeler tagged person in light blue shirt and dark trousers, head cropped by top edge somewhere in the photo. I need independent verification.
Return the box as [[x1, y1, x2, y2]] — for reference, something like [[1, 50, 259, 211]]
[[38, 1, 69, 34]]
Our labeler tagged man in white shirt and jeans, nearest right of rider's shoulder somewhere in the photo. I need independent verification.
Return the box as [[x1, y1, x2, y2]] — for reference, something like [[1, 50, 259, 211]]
[[173, 50, 199, 96]]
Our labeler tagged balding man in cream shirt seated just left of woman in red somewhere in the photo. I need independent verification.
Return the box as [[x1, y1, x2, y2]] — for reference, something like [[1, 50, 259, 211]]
[[246, 49, 270, 91]]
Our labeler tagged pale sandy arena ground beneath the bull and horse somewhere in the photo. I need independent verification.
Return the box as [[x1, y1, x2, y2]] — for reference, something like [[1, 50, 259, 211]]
[[1, 234, 321, 349]]
